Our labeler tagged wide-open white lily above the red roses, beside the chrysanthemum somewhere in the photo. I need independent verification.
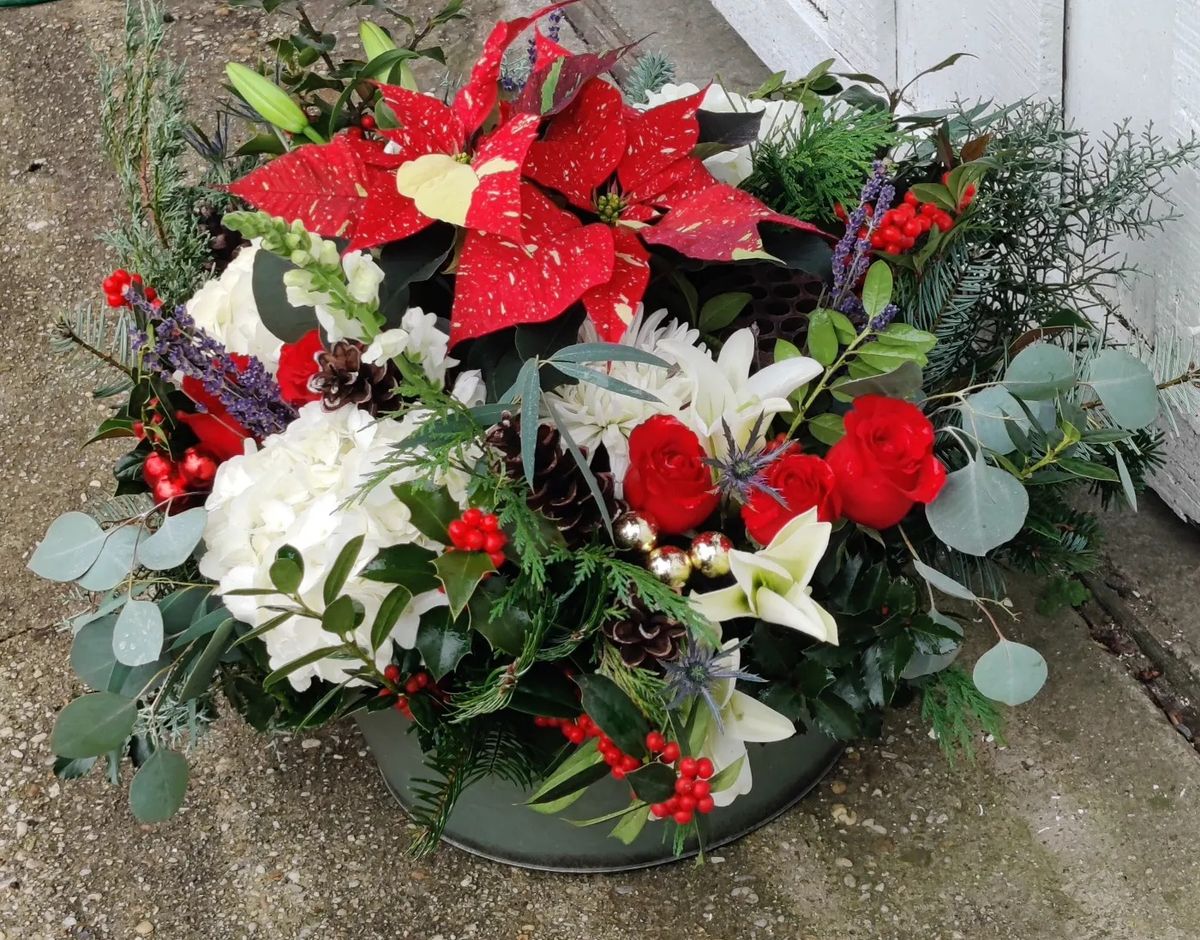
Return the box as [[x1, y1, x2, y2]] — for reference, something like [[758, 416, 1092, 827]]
[[661, 328, 824, 455]]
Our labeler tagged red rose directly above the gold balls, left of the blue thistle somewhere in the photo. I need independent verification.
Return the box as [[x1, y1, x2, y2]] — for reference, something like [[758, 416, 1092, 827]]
[[625, 414, 720, 535]]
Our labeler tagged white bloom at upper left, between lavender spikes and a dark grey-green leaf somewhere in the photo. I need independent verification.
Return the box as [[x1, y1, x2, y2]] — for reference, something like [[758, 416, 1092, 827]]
[[187, 239, 283, 375]]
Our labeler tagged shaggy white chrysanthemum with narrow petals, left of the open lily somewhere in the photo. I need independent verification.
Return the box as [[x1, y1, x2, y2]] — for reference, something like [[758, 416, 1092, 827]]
[[548, 310, 707, 486]]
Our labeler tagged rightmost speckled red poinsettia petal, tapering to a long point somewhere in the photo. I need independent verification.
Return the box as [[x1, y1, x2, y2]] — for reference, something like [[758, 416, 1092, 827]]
[[642, 182, 827, 261]]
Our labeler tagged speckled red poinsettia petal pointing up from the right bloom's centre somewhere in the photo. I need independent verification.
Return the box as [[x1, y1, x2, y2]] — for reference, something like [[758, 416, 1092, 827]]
[[526, 78, 625, 209]]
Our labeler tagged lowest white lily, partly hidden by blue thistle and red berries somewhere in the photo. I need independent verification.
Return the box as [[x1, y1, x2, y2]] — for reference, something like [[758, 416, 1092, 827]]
[[697, 640, 796, 807]]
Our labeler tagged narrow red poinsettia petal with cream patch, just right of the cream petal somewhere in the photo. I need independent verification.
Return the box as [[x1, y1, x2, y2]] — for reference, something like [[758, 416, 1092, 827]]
[[467, 114, 541, 240]]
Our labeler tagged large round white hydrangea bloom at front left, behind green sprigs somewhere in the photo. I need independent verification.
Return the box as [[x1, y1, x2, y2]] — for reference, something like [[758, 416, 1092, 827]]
[[200, 402, 466, 690]]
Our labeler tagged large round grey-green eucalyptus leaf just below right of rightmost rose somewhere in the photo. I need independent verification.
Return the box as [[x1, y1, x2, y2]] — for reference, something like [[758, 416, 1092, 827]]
[[925, 460, 1030, 555]]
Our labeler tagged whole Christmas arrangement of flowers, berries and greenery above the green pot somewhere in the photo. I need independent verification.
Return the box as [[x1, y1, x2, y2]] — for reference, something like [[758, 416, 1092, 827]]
[[30, 2, 1198, 850]]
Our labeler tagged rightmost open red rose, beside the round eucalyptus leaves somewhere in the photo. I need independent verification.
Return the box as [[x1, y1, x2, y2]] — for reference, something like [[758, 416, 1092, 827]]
[[826, 395, 946, 529]]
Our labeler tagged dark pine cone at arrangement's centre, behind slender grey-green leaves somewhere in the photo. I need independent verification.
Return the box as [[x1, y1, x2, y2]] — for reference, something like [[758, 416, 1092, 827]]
[[487, 412, 616, 545]]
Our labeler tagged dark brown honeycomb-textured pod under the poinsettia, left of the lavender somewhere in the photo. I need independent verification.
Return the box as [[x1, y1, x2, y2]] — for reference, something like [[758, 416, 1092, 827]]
[[709, 264, 823, 369]]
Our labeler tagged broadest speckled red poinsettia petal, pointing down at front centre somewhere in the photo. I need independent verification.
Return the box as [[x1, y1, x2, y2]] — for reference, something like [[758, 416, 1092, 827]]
[[450, 185, 614, 346]]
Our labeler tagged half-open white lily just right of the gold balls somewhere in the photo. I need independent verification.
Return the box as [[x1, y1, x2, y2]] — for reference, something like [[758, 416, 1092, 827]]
[[691, 508, 838, 646]]
